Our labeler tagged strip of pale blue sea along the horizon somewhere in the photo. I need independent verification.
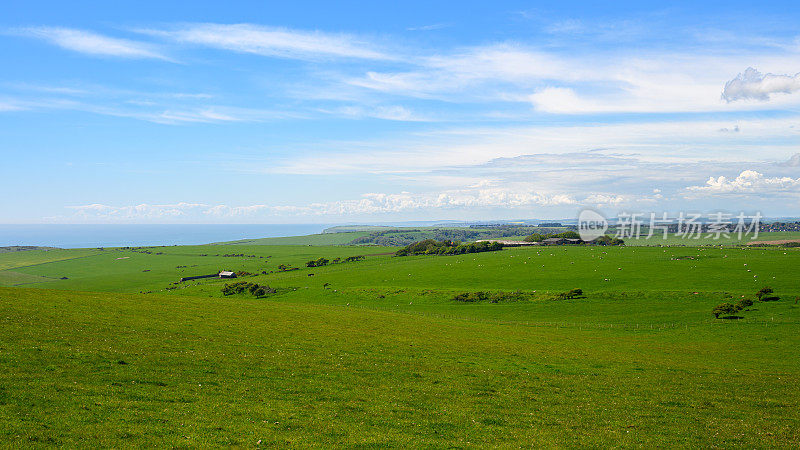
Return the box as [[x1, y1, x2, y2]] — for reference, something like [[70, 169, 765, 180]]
[[0, 224, 333, 248]]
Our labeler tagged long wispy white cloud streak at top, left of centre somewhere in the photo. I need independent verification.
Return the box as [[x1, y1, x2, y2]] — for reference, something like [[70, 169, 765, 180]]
[[142, 23, 391, 59]]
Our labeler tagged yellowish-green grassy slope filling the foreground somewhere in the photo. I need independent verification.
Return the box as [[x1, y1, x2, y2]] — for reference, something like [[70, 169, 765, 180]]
[[0, 288, 800, 447]]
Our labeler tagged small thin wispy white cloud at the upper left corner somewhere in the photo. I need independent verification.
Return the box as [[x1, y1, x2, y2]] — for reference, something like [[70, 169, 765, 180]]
[[13, 27, 170, 61]]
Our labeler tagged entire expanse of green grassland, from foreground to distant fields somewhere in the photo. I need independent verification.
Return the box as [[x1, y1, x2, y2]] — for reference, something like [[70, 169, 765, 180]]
[[0, 235, 800, 448]]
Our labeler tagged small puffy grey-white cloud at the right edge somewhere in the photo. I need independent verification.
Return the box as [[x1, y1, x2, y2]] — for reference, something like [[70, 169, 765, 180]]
[[722, 67, 800, 102]]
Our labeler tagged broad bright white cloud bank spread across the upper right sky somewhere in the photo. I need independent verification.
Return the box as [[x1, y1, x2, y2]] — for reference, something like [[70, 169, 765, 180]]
[[345, 39, 800, 114]]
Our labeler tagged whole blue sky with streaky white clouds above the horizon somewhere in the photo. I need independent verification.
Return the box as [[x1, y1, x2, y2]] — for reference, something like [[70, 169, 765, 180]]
[[0, 1, 800, 223]]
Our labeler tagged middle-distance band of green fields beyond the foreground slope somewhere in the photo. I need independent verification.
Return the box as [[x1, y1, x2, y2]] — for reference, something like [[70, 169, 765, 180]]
[[0, 245, 800, 295]]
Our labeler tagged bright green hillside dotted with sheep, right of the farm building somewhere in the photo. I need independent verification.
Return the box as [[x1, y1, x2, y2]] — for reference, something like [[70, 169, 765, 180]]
[[180, 246, 800, 295]]
